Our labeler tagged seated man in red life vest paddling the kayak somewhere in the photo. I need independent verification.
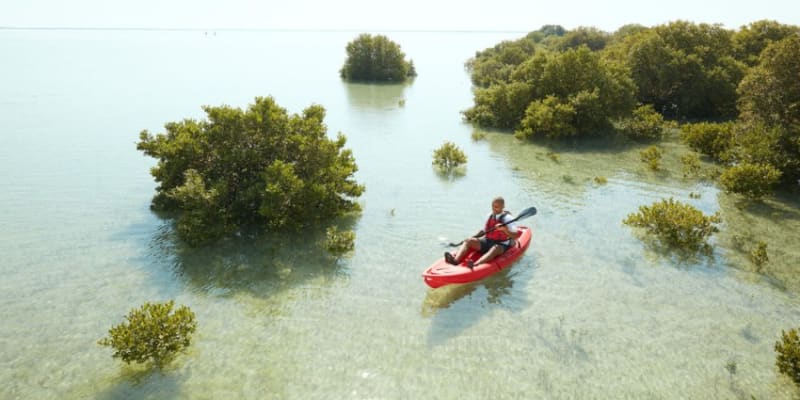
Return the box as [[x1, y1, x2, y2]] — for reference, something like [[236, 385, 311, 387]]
[[444, 197, 520, 269]]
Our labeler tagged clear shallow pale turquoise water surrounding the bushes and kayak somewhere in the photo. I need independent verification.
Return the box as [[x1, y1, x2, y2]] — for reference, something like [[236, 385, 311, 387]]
[[0, 31, 800, 399]]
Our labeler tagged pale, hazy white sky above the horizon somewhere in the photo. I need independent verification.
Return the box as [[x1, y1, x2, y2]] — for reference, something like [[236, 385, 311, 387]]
[[0, 0, 800, 32]]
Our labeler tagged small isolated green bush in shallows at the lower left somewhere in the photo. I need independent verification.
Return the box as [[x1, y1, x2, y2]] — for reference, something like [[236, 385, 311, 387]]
[[98, 300, 197, 368]]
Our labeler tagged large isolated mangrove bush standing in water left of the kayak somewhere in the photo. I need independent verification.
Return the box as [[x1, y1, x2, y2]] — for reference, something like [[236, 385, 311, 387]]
[[137, 97, 364, 245]]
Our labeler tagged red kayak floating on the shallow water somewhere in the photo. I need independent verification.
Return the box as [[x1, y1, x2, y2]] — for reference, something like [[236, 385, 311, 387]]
[[422, 226, 531, 288]]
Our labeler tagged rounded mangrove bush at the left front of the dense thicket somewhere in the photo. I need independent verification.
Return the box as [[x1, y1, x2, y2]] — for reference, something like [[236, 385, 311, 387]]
[[464, 46, 635, 134]]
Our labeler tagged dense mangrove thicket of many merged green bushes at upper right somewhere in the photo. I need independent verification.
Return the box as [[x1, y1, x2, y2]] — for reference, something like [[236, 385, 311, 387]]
[[464, 21, 800, 198]]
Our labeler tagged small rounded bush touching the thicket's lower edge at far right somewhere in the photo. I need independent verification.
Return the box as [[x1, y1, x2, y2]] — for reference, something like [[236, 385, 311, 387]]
[[719, 163, 781, 199]]
